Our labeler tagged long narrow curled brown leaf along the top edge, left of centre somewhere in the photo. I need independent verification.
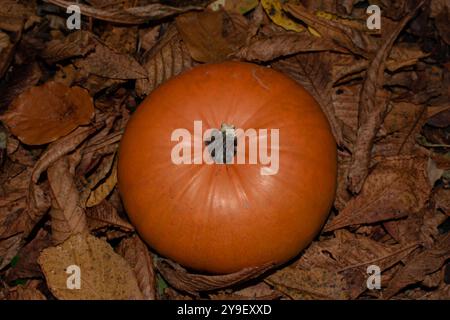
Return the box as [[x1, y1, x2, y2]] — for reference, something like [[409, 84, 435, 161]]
[[44, 0, 202, 24]]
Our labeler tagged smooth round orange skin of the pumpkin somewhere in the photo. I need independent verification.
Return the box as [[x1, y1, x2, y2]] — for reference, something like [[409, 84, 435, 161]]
[[118, 62, 337, 274]]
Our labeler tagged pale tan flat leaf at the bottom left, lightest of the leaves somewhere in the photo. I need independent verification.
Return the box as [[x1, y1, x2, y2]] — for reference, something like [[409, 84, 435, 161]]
[[38, 233, 142, 300]]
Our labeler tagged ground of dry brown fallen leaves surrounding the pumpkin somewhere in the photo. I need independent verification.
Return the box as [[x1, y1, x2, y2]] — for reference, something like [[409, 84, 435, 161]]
[[0, 0, 450, 299]]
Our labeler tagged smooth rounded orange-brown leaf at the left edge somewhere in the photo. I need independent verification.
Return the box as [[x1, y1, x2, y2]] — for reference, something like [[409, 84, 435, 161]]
[[0, 82, 94, 145]]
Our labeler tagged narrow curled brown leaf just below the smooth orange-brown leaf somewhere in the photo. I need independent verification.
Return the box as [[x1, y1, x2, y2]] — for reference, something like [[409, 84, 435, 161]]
[[32, 124, 101, 183]]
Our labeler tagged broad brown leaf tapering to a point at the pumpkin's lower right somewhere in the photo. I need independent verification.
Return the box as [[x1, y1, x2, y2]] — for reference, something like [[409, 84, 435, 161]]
[[325, 156, 432, 231]]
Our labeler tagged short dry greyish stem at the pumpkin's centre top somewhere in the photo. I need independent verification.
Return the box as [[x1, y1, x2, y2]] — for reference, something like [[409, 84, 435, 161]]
[[205, 123, 237, 164]]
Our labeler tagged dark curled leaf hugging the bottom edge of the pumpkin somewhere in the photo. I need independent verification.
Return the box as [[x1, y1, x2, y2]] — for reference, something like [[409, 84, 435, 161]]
[[156, 259, 273, 294]]
